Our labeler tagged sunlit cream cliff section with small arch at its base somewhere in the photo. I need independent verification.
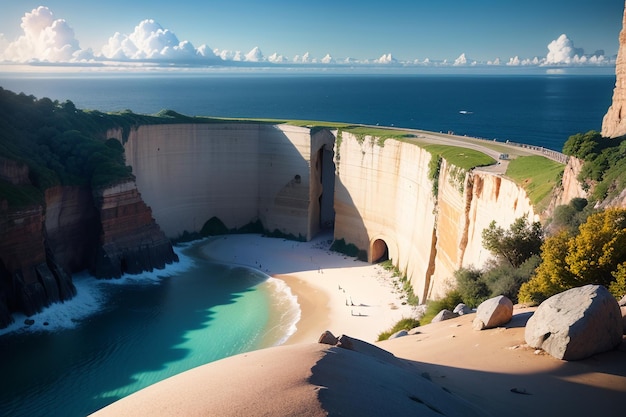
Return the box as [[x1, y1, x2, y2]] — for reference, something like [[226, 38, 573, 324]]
[[335, 132, 536, 301]]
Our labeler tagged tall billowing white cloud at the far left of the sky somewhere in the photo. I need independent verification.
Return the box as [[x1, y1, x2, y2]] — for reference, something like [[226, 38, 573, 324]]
[[0, 6, 91, 62]]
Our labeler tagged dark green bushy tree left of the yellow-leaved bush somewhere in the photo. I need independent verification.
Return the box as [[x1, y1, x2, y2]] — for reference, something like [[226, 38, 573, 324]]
[[482, 217, 543, 268]]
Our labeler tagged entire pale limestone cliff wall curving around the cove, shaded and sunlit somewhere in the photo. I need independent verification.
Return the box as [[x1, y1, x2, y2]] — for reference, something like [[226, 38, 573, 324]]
[[109, 122, 536, 301]]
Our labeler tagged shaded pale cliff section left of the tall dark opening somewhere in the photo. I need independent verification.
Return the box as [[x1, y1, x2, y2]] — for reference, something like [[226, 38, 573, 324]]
[[114, 123, 334, 238]]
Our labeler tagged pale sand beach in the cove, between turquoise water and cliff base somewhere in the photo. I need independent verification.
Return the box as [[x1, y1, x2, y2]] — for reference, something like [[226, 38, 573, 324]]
[[202, 235, 414, 343]]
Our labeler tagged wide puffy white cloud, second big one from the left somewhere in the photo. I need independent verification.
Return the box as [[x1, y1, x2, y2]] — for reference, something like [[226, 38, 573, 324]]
[[97, 19, 217, 61]]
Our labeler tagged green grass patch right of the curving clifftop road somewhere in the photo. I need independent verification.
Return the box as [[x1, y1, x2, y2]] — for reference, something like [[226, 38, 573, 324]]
[[506, 155, 565, 208]]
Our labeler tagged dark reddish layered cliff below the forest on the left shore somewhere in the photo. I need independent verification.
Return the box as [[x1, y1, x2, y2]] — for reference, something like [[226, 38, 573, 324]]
[[0, 160, 177, 328]]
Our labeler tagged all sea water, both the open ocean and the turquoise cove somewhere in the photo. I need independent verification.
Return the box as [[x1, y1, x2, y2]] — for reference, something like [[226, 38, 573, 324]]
[[0, 73, 615, 417]]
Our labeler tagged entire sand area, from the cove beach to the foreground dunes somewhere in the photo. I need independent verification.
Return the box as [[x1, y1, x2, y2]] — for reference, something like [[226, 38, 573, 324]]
[[95, 235, 626, 417]]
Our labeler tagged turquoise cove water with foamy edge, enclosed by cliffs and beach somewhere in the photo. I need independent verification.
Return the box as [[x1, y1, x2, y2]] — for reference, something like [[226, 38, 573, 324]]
[[0, 239, 299, 417]]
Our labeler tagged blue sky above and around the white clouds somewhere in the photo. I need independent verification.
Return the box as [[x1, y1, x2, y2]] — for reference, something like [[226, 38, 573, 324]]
[[0, 0, 624, 67]]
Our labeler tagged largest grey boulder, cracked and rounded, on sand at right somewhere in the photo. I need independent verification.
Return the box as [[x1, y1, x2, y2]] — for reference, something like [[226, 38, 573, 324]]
[[525, 285, 623, 361]]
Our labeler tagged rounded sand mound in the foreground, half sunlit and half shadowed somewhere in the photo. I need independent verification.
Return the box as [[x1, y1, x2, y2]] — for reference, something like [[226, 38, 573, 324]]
[[94, 336, 484, 417]]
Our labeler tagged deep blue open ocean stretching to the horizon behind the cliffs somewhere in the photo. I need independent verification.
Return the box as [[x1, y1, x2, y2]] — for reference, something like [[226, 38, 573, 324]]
[[0, 73, 615, 151]]
